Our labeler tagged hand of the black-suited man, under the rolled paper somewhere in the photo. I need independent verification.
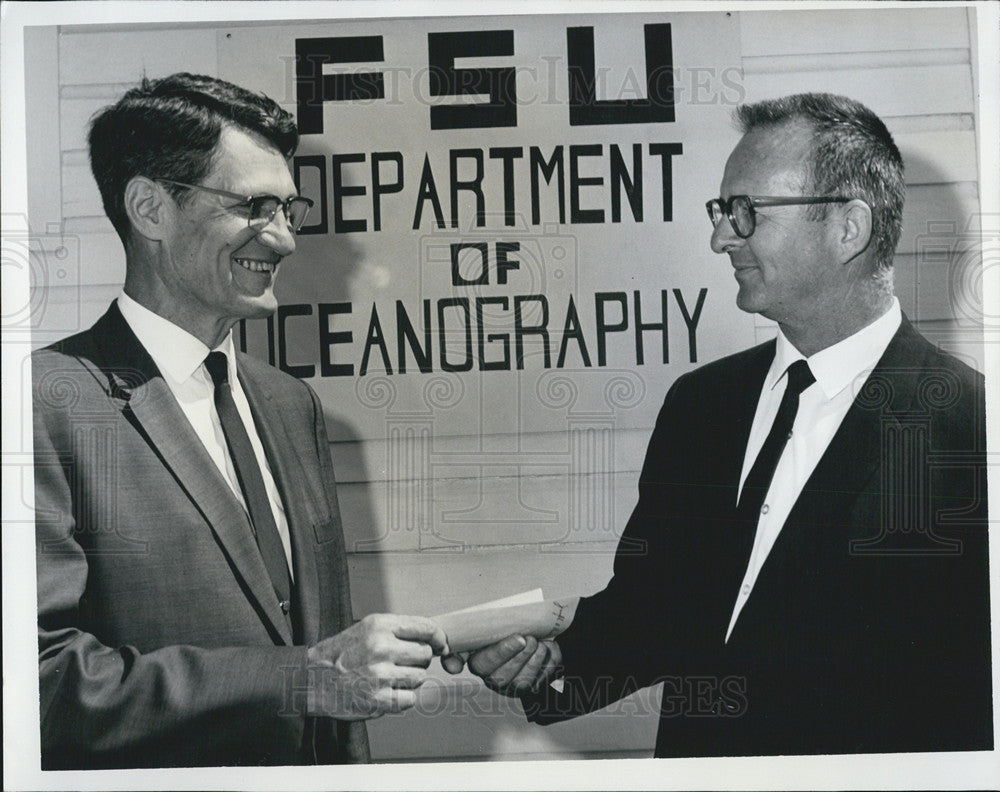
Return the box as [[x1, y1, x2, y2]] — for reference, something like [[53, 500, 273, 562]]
[[441, 635, 562, 696]]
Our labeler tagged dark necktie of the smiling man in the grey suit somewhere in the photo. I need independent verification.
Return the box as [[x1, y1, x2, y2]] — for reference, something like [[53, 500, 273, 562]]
[[205, 352, 291, 615]]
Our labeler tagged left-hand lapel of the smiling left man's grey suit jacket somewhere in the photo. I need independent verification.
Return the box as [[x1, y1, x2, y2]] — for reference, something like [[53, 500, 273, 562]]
[[95, 304, 291, 643]]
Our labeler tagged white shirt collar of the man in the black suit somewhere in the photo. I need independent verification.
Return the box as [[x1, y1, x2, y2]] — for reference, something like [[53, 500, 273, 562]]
[[766, 297, 903, 399]]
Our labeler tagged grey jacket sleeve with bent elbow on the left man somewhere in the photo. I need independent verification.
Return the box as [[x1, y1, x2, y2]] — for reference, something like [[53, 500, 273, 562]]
[[34, 374, 306, 769]]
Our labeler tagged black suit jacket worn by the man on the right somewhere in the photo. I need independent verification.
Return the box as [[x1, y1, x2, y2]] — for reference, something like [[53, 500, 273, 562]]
[[525, 318, 993, 756]]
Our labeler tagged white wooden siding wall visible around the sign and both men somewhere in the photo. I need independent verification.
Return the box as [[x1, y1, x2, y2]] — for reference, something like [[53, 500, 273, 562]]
[[27, 8, 982, 761]]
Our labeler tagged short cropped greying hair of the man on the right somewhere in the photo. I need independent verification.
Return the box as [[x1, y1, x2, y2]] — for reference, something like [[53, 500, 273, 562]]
[[736, 93, 905, 270]]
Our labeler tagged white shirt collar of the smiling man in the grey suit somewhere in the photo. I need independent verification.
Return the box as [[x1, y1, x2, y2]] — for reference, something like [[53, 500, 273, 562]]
[[118, 291, 236, 382]]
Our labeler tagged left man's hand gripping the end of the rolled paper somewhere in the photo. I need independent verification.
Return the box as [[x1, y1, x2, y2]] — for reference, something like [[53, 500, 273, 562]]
[[306, 614, 447, 720]]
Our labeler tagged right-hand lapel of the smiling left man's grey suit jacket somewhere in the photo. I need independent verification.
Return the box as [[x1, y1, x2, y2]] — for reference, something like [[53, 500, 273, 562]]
[[237, 362, 319, 644]]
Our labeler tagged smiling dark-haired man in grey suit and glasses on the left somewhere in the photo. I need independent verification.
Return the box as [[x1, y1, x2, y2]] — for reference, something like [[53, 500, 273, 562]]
[[32, 74, 445, 769]]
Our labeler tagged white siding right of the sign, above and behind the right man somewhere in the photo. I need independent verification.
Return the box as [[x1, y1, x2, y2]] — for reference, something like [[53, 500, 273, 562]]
[[740, 8, 983, 370]]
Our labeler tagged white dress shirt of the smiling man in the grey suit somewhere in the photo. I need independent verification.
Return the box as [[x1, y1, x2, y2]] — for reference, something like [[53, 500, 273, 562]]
[[118, 292, 294, 579]]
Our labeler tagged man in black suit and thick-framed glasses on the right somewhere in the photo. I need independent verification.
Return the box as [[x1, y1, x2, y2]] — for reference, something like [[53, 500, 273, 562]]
[[452, 94, 993, 756]]
